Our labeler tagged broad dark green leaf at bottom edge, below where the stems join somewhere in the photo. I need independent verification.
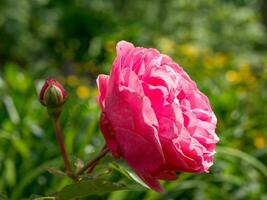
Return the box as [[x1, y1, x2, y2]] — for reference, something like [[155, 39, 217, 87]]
[[58, 179, 127, 200]]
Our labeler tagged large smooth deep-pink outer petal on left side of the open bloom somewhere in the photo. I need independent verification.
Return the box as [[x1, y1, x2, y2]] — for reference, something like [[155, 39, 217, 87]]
[[106, 88, 164, 171]]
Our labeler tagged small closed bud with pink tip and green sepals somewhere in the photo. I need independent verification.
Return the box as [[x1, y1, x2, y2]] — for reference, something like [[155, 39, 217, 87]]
[[39, 78, 68, 108]]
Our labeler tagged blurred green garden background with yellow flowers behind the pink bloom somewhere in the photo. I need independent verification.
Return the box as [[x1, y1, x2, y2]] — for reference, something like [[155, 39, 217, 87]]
[[0, 0, 267, 200]]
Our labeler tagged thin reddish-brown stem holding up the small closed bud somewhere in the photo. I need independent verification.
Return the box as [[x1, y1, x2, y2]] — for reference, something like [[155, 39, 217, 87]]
[[53, 117, 78, 181]]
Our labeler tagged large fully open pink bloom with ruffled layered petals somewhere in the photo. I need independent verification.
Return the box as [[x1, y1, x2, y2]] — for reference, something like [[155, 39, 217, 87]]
[[97, 41, 219, 192]]
